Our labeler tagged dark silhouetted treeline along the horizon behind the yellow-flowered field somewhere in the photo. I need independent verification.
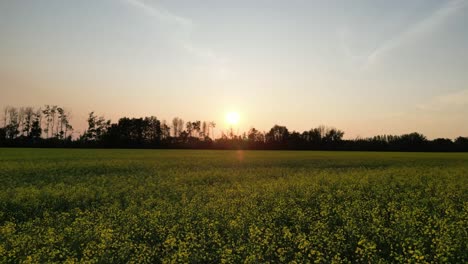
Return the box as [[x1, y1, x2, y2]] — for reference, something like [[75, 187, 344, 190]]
[[0, 105, 468, 151]]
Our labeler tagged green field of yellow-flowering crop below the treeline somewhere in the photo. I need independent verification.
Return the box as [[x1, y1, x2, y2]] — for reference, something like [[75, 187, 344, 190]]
[[0, 149, 468, 263]]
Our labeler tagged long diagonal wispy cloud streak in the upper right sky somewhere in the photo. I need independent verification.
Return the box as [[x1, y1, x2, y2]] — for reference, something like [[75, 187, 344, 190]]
[[364, 0, 468, 68]]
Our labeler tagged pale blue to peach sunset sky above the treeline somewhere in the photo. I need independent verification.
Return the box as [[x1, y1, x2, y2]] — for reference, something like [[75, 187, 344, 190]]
[[0, 0, 468, 138]]
